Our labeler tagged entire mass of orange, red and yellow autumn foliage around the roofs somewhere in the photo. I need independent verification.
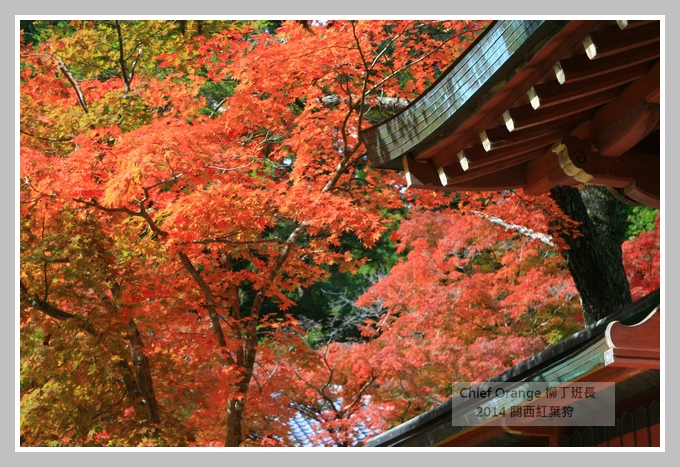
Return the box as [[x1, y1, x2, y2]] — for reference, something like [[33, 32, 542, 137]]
[[19, 21, 658, 446]]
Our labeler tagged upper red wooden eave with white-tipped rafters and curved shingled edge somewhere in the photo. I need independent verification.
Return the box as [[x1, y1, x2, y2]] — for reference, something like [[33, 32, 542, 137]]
[[361, 20, 661, 207]]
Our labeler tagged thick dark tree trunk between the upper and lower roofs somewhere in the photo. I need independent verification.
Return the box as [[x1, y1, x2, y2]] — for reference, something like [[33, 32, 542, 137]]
[[550, 185, 632, 324]]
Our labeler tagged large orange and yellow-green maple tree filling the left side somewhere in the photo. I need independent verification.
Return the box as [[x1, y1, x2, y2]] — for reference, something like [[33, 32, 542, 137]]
[[19, 21, 484, 446]]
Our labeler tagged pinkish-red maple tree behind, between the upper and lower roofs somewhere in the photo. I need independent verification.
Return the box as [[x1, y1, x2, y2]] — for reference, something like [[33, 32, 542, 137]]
[[316, 191, 660, 442]]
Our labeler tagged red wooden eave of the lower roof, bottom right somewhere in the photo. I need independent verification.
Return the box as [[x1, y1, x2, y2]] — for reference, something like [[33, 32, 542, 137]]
[[367, 290, 660, 447]]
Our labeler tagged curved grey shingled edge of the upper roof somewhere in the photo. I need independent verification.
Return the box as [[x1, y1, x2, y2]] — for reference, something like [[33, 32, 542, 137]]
[[360, 20, 568, 169]]
